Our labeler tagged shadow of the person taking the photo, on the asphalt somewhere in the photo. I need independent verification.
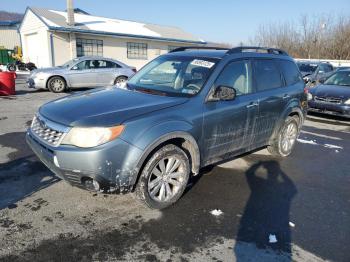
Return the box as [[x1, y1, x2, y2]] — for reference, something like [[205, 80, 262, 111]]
[[234, 160, 297, 261]]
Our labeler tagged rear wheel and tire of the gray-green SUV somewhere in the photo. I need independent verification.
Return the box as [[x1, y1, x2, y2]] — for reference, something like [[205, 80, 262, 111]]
[[267, 116, 300, 157]]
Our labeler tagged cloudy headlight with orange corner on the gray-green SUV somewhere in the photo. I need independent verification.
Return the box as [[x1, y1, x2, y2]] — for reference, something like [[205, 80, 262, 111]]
[[61, 125, 124, 147]]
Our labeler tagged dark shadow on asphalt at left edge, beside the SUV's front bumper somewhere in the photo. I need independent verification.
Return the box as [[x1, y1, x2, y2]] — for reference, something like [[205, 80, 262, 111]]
[[0, 132, 59, 210]]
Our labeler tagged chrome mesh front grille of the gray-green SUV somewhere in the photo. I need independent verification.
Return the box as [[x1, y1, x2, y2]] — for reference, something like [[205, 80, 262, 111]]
[[31, 116, 64, 146]]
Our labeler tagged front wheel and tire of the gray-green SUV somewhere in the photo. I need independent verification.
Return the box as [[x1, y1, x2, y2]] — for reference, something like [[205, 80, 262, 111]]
[[135, 144, 190, 209]]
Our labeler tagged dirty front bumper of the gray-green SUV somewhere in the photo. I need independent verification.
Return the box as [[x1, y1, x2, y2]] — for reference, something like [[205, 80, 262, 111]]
[[26, 129, 142, 193]]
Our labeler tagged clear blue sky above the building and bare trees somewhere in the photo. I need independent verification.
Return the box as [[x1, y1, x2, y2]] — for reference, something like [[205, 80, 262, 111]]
[[0, 0, 350, 44]]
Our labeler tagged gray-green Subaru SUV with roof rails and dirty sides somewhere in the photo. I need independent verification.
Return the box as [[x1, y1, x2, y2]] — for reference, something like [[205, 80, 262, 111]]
[[26, 47, 307, 209]]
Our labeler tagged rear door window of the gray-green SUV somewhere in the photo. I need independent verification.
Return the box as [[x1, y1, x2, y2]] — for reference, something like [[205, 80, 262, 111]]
[[254, 59, 283, 91]]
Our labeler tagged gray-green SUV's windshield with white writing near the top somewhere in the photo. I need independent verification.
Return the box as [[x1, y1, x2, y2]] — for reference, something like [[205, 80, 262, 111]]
[[127, 56, 218, 96]]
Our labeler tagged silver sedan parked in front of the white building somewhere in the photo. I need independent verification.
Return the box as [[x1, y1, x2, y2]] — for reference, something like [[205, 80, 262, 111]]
[[28, 56, 136, 93]]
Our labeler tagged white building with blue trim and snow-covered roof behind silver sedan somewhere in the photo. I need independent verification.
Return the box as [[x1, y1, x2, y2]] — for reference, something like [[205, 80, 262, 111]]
[[19, 7, 205, 69]]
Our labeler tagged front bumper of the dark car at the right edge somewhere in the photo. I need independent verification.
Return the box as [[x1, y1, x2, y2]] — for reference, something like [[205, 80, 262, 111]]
[[308, 100, 350, 117]]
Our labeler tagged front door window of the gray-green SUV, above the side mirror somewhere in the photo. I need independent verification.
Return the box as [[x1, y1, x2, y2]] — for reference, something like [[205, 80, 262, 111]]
[[215, 61, 253, 95]]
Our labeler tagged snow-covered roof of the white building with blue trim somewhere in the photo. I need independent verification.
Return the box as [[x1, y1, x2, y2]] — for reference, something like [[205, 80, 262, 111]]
[[27, 7, 205, 44]]
